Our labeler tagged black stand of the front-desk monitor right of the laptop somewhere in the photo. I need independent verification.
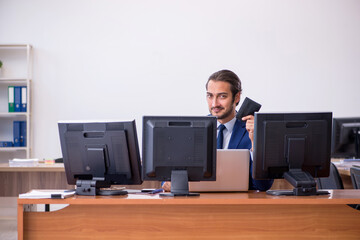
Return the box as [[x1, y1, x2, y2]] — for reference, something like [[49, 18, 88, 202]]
[[266, 169, 330, 196]]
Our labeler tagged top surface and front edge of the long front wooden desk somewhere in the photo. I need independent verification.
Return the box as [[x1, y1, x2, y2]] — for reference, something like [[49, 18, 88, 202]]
[[18, 189, 360, 205]]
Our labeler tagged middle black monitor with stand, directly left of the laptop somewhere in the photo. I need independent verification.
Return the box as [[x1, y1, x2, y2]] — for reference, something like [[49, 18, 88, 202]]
[[142, 116, 217, 196]]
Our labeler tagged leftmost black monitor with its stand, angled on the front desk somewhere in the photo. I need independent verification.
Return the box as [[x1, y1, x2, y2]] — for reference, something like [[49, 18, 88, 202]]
[[58, 120, 142, 195]]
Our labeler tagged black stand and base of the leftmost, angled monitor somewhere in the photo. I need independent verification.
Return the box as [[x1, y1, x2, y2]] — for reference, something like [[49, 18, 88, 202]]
[[76, 178, 128, 196]]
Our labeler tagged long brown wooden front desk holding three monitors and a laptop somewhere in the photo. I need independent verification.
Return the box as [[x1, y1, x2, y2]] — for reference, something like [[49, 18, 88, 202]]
[[18, 190, 360, 240]]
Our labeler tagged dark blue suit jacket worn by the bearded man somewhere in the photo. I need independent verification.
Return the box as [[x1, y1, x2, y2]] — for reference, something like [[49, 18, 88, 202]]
[[228, 119, 274, 191]]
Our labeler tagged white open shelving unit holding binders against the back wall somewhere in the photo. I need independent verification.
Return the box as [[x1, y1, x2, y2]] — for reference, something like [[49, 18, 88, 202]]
[[0, 44, 32, 162]]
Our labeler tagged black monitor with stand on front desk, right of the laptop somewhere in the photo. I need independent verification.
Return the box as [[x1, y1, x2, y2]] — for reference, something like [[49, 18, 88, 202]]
[[253, 112, 332, 195]]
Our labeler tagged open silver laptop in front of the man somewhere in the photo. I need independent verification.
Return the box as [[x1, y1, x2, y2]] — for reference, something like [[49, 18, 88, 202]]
[[189, 149, 250, 192]]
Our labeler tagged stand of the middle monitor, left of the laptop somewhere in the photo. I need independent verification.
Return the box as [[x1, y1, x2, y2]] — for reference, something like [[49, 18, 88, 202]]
[[160, 170, 200, 197]]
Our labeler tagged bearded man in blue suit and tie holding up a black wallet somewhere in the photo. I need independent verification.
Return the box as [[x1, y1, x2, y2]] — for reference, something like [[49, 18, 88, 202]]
[[163, 70, 273, 191]]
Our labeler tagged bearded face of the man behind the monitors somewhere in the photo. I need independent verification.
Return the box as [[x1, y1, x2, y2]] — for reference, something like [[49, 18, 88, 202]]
[[206, 80, 240, 123]]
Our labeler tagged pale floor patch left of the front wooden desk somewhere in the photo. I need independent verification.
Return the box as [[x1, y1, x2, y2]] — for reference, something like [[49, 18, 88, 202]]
[[0, 197, 17, 240]]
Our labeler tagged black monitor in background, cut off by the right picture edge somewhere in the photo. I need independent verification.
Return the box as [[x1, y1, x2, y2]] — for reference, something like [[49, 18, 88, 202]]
[[331, 117, 360, 158]]
